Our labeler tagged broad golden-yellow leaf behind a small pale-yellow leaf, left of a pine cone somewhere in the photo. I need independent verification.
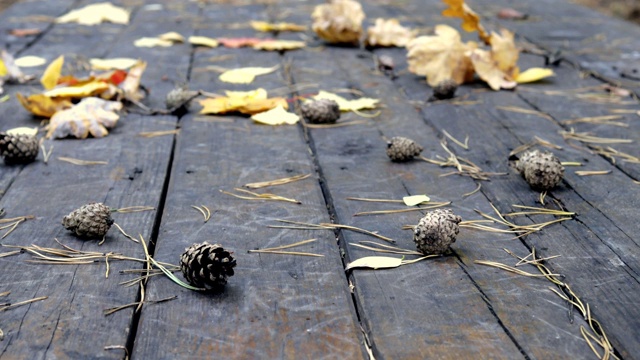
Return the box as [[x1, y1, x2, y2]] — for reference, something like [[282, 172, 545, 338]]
[[200, 89, 289, 115]]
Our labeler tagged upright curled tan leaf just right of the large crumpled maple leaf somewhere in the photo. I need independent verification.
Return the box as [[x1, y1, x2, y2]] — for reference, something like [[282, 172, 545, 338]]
[[471, 29, 520, 90]]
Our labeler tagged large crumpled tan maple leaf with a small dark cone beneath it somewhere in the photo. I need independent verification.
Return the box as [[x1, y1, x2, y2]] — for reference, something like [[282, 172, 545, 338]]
[[407, 25, 477, 86]]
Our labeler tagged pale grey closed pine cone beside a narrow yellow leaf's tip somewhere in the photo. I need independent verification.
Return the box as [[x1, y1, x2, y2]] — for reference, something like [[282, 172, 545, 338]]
[[413, 209, 462, 254]]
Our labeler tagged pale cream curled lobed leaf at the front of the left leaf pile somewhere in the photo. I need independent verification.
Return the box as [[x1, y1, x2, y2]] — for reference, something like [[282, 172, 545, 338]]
[[46, 97, 122, 139]]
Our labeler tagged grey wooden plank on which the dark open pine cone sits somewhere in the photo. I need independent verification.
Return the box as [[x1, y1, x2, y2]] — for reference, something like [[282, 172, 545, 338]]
[[133, 5, 363, 359]]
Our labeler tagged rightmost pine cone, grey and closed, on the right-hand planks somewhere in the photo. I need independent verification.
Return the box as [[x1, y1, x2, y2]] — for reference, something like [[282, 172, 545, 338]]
[[516, 150, 564, 191]]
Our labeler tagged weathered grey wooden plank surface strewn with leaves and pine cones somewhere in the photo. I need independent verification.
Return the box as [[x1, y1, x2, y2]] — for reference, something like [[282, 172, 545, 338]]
[[0, 0, 640, 359]]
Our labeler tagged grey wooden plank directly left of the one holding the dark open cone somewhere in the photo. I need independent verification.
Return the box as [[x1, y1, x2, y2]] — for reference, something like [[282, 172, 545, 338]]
[[0, 0, 198, 358]]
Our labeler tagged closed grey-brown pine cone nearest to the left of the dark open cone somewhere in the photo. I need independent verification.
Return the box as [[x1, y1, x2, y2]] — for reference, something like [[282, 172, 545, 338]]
[[62, 203, 113, 239]]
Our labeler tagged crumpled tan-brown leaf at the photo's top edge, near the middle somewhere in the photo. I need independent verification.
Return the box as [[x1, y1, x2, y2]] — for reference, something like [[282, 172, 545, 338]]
[[311, 0, 365, 44]]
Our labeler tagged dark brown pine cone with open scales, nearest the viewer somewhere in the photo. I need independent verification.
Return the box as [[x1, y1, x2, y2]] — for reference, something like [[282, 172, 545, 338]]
[[180, 241, 236, 290]]
